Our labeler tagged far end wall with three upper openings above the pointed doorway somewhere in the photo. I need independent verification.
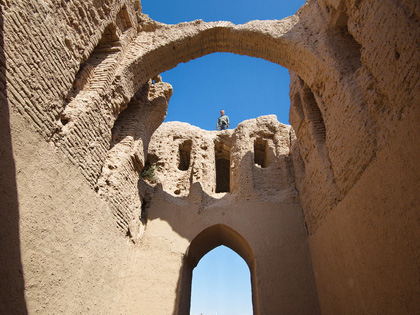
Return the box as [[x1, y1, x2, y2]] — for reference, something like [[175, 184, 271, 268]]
[[144, 115, 319, 314]]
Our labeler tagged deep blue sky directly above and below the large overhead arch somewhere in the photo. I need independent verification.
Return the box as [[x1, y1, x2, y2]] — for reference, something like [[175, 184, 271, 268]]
[[141, 0, 305, 130]]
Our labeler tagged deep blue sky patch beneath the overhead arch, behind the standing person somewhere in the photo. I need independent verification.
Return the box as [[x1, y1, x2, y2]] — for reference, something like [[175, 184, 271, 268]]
[[162, 53, 290, 130]]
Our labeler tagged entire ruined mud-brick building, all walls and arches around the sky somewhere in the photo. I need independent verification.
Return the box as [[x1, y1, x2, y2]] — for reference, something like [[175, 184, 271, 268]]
[[0, 0, 420, 315]]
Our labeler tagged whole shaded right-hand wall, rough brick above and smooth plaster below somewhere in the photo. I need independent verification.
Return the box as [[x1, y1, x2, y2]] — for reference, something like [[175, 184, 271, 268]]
[[290, 1, 420, 314]]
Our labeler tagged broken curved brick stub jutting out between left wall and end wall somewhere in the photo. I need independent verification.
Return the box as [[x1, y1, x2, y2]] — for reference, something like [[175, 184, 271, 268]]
[[95, 78, 172, 237]]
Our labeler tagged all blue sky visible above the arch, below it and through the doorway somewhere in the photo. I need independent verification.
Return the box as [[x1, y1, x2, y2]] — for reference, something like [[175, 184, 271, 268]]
[[141, 0, 305, 315]]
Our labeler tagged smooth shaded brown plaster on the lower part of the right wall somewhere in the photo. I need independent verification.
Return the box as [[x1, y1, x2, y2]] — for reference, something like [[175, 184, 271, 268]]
[[309, 109, 420, 314]]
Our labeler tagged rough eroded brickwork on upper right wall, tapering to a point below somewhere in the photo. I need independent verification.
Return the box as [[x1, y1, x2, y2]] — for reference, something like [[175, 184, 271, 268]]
[[290, 1, 420, 233]]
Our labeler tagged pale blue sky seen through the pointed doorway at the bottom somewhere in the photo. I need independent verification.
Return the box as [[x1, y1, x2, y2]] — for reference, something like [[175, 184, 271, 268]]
[[190, 246, 253, 315]]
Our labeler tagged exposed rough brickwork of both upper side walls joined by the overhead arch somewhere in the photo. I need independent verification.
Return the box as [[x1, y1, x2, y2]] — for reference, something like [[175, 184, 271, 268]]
[[3, 0, 419, 235]]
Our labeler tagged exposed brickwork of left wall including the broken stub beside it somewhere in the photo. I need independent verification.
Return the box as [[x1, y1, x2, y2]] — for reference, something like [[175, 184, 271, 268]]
[[2, 0, 176, 237]]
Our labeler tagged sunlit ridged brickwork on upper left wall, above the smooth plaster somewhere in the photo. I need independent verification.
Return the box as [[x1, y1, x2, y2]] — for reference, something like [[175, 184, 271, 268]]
[[3, 1, 139, 190]]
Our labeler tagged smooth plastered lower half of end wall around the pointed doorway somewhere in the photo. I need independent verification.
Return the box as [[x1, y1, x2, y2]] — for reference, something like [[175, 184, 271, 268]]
[[146, 193, 320, 315]]
